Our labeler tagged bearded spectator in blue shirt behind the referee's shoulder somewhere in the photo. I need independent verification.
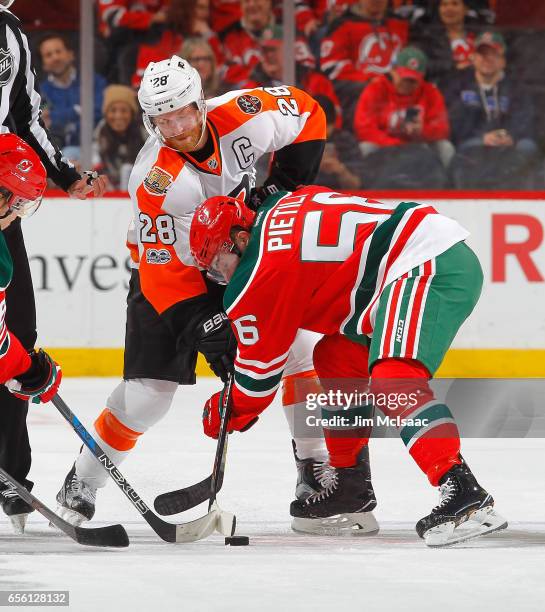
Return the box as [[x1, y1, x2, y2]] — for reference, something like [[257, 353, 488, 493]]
[[38, 34, 106, 160]]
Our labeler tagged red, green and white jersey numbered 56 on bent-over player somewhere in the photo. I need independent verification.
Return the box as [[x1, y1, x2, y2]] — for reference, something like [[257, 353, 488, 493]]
[[224, 186, 469, 415]]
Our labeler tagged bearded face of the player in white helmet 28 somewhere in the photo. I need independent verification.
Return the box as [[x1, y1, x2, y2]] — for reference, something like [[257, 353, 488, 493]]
[[151, 104, 202, 153]]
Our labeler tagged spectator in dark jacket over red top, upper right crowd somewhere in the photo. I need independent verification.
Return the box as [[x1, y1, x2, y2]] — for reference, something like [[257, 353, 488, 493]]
[[411, 0, 479, 91]]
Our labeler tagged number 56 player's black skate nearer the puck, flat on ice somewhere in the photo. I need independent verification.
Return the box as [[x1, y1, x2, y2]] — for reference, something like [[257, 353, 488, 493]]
[[290, 447, 379, 535]]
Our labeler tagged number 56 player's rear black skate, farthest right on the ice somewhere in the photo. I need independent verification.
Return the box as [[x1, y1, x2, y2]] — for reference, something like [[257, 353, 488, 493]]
[[416, 462, 507, 547]]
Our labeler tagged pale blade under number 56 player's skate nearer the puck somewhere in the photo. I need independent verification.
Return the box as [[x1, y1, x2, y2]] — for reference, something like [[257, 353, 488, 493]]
[[291, 512, 379, 537]]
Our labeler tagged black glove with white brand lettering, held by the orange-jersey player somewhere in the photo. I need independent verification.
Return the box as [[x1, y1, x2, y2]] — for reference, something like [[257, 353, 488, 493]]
[[195, 312, 237, 382]]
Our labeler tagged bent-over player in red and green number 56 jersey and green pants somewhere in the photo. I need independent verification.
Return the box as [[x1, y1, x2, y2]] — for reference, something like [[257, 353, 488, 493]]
[[190, 186, 507, 546]]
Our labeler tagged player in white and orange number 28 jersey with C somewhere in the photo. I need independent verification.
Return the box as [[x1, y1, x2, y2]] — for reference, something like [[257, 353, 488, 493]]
[[53, 56, 368, 522]]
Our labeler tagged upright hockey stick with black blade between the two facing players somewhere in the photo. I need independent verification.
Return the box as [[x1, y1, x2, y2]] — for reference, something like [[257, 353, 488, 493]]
[[153, 375, 233, 516]]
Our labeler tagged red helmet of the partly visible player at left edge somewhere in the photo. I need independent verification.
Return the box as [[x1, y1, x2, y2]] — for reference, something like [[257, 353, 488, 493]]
[[0, 134, 47, 217]]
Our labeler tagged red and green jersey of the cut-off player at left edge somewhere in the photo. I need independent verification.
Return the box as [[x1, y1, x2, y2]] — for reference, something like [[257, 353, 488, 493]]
[[0, 232, 30, 383]]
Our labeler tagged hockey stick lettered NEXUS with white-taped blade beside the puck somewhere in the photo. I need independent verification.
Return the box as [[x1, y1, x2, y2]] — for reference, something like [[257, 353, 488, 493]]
[[51, 393, 234, 542]]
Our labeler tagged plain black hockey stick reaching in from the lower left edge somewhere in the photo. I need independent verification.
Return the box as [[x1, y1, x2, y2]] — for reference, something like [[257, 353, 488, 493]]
[[0, 468, 129, 548]]
